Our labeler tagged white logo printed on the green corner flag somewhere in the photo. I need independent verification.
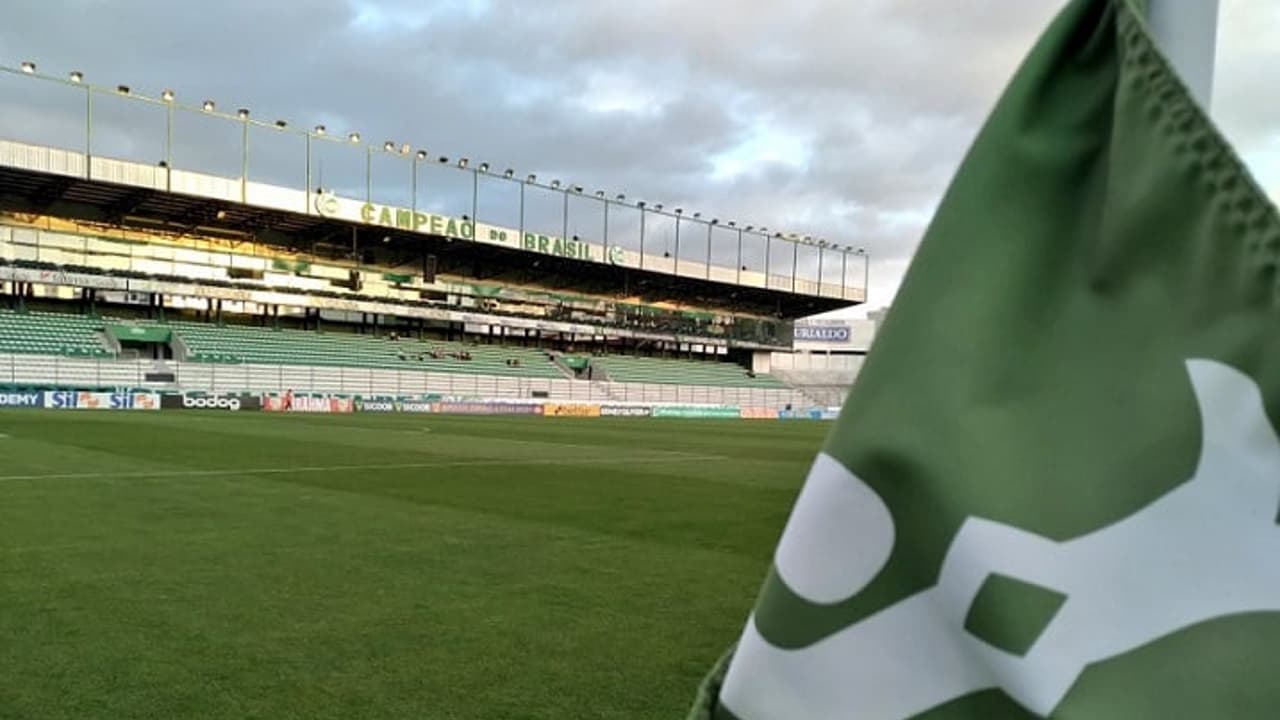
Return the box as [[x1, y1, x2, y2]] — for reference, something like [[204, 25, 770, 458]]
[[721, 360, 1280, 720]]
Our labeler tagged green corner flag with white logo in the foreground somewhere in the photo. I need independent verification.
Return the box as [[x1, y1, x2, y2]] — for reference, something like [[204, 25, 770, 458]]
[[691, 0, 1280, 720]]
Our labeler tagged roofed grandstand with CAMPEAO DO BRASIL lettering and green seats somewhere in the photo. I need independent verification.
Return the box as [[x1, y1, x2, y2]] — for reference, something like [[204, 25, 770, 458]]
[[0, 68, 868, 407]]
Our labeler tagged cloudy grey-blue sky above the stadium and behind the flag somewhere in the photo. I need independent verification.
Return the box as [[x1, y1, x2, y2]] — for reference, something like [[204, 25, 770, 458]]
[[0, 0, 1280, 315]]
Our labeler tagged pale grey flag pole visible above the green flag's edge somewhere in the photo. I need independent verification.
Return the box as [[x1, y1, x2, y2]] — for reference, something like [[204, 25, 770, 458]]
[[1147, 0, 1219, 110]]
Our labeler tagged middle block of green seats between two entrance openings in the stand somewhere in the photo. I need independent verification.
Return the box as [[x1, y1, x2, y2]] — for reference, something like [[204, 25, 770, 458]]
[[169, 323, 564, 378]]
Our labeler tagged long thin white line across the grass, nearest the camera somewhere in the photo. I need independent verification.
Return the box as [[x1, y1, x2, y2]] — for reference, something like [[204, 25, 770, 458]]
[[0, 455, 724, 482]]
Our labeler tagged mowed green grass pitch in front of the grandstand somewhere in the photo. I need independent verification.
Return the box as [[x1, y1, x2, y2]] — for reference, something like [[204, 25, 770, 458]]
[[0, 411, 829, 720]]
